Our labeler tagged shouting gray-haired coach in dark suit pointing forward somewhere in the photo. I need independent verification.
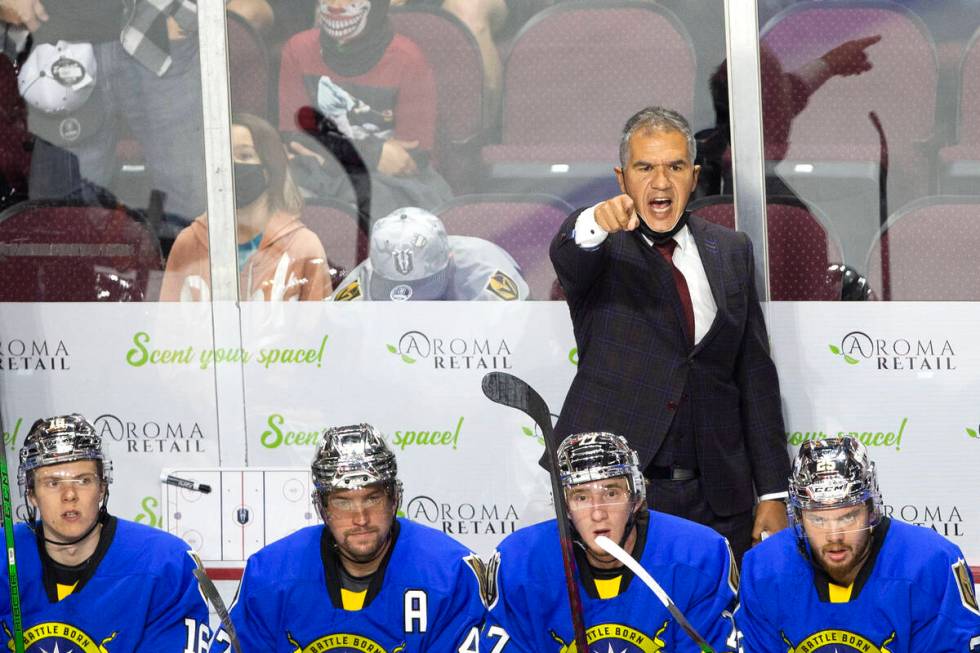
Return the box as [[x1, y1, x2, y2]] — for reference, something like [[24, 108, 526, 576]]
[[550, 107, 789, 560]]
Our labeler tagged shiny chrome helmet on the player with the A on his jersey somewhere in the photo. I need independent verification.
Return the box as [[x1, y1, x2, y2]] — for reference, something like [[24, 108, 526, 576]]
[[312, 424, 402, 511]]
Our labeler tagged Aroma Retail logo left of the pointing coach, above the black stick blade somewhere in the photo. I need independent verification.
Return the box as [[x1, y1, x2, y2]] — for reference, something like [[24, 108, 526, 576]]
[[385, 331, 513, 370]]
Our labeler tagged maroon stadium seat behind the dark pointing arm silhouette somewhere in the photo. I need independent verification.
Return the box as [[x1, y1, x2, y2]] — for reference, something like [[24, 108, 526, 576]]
[[762, 0, 938, 260]]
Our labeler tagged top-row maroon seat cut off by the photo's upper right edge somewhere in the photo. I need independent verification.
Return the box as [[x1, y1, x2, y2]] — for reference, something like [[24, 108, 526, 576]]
[[939, 29, 980, 195]]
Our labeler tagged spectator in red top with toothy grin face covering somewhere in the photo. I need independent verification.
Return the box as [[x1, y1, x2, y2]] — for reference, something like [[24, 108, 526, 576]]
[[279, 0, 450, 215]]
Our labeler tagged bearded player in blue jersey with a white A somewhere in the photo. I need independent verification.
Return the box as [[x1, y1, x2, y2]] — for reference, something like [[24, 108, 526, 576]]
[[212, 424, 484, 653]]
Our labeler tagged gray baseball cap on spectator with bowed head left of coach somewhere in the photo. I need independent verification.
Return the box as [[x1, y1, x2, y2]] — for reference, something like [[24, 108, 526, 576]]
[[368, 206, 451, 301]]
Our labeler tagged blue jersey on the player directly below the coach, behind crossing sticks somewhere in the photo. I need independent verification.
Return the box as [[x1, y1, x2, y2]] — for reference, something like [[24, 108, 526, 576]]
[[480, 511, 738, 653]]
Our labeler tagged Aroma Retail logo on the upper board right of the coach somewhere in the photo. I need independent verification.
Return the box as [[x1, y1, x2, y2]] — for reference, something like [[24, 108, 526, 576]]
[[828, 331, 956, 371]]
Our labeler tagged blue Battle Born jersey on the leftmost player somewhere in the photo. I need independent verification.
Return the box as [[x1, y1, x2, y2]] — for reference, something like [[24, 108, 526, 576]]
[[0, 518, 210, 653]]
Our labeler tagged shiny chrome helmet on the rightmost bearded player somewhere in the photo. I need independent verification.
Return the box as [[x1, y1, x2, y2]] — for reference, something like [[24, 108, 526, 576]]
[[788, 437, 882, 534]]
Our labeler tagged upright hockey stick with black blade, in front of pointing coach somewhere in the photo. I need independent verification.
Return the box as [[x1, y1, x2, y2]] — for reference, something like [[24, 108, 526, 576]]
[[483, 372, 589, 653]]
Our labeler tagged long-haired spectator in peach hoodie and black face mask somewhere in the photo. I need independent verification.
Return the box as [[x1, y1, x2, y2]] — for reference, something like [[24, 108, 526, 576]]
[[160, 114, 332, 301]]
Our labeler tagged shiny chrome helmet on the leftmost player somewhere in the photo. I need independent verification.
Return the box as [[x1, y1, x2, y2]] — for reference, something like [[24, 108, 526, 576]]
[[17, 413, 112, 496]]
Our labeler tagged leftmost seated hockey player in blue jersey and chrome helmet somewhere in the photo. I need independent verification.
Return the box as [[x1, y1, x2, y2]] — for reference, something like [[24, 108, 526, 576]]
[[0, 414, 211, 653]]
